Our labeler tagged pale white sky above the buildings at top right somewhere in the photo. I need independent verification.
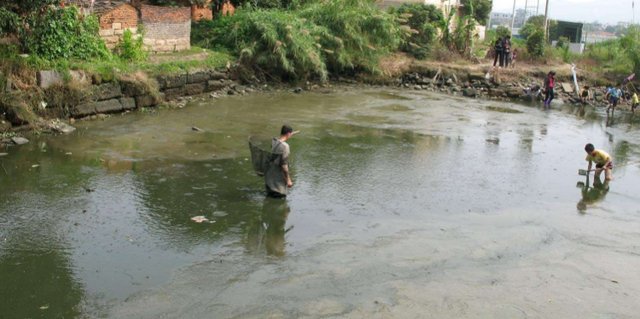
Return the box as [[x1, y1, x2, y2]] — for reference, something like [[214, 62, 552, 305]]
[[493, 0, 640, 24]]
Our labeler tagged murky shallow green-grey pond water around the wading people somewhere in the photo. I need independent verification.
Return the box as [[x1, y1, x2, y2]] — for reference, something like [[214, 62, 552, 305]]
[[0, 90, 640, 318]]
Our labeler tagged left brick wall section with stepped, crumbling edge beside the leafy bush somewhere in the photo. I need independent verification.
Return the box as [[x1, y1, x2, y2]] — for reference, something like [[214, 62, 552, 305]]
[[100, 3, 139, 50]]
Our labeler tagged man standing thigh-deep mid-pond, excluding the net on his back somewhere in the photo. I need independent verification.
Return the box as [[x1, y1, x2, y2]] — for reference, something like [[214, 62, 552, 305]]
[[264, 125, 293, 197]]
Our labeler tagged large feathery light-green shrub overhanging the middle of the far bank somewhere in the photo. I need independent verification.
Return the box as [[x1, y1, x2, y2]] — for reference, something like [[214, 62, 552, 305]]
[[194, 0, 409, 79]]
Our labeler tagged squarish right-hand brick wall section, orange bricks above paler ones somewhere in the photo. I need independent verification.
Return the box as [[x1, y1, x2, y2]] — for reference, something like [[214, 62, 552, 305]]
[[140, 5, 191, 53]]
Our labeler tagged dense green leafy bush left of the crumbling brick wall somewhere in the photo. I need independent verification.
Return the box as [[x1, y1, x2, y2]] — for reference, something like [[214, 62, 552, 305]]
[[21, 7, 111, 60]]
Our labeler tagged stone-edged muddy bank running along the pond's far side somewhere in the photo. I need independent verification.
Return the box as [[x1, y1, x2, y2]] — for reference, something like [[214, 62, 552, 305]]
[[0, 65, 625, 149]]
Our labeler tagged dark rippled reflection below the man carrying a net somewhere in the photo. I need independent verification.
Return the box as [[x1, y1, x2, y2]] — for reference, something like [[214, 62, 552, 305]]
[[247, 197, 293, 258]]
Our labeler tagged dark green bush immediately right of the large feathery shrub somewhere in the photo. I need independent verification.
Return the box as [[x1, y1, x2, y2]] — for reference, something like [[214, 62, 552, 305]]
[[389, 3, 442, 59]]
